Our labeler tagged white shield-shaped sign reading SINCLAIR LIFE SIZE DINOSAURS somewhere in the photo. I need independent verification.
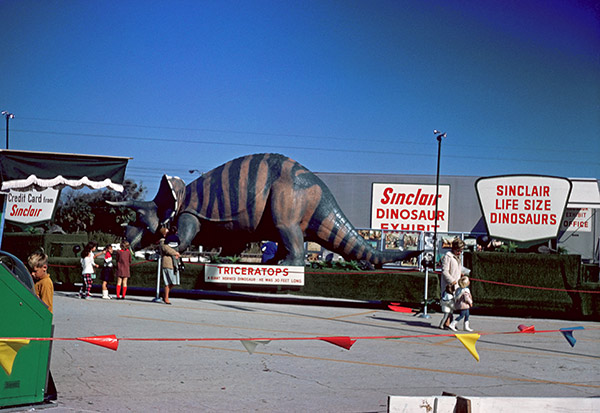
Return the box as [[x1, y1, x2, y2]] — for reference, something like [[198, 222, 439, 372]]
[[475, 175, 572, 242]]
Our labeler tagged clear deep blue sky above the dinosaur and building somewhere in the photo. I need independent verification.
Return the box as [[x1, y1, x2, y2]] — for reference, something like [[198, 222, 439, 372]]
[[0, 0, 600, 198]]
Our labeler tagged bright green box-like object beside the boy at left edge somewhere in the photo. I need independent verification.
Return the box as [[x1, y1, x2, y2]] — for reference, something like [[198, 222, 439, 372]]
[[0, 251, 52, 408]]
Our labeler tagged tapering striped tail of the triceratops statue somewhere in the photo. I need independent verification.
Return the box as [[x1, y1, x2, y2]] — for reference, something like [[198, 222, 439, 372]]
[[307, 183, 423, 268]]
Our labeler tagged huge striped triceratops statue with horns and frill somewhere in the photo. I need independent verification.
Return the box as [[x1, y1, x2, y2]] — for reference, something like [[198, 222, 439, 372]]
[[111, 153, 421, 267]]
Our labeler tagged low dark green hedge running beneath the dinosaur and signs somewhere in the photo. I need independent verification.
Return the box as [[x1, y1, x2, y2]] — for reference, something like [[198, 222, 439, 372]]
[[50, 252, 600, 319]]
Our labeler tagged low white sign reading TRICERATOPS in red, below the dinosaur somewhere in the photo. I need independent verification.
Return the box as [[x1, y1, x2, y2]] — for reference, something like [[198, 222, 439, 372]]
[[204, 264, 304, 286]]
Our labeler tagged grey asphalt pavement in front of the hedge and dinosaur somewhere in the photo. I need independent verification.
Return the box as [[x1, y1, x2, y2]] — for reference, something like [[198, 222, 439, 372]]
[[10, 292, 600, 413]]
